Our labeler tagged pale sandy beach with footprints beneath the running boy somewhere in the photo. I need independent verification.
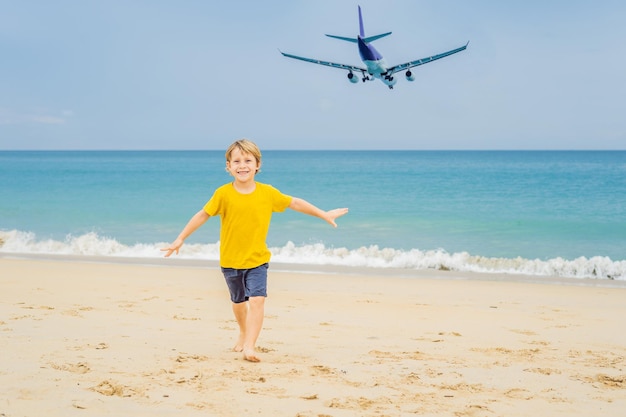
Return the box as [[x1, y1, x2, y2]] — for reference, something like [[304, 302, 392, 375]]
[[0, 258, 626, 417]]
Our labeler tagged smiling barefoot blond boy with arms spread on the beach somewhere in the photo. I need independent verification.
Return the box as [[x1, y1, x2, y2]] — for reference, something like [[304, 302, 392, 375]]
[[161, 139, 348, 362]]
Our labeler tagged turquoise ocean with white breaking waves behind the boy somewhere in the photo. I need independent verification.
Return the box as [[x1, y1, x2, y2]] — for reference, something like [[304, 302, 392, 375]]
[[0, 150, 626, 280]]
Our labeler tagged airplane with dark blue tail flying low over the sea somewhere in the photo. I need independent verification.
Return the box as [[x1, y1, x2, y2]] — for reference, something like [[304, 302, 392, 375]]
[[279, 6, 469, 89]]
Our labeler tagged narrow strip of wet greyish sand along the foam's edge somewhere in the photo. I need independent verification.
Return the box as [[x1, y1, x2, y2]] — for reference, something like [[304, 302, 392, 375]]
[[0, 252, 626, 288]]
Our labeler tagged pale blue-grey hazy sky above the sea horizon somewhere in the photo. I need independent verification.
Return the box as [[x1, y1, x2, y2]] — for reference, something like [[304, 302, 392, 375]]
[[0, 0, 626, 150]]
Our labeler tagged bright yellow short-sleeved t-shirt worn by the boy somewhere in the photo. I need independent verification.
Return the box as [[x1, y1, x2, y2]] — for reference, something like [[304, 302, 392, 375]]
[[204, 182, 291, 269]]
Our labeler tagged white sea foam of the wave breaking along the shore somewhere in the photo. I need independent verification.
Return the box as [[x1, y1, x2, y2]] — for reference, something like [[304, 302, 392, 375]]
[[0, 230, 626, 280]]
